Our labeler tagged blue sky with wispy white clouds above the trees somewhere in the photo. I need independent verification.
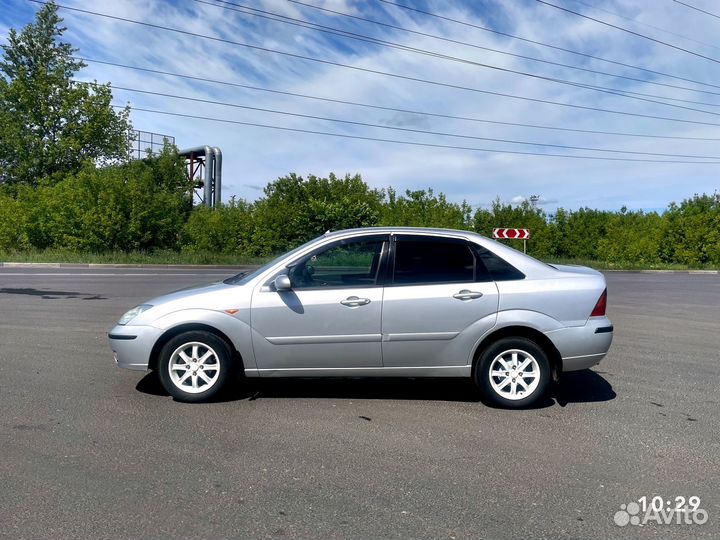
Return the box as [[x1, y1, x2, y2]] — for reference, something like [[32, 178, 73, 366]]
[[0, 0, 720, 212]]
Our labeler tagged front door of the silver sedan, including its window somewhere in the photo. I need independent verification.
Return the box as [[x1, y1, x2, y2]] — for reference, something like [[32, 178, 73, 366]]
[[251, 234, 389, 375]]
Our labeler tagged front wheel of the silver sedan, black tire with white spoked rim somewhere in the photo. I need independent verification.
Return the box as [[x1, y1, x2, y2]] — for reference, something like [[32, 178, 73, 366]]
[[158, 330, 233, 403]]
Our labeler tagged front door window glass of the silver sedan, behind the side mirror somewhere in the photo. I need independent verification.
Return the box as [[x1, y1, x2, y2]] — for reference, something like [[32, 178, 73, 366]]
[[288, 239, 383, 289]]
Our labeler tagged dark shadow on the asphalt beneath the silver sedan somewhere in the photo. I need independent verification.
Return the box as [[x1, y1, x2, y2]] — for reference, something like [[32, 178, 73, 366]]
[[136, 369, 616, 409]]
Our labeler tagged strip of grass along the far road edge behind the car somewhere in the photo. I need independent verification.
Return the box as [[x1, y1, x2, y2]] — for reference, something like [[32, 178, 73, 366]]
[[0, 249, 718, 270]]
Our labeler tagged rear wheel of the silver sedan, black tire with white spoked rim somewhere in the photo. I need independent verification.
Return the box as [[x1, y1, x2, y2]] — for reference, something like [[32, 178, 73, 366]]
[[474, 337, 552, 409]]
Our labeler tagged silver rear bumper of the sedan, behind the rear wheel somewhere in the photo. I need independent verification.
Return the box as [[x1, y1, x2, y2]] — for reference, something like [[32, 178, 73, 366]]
[[545, 317, 614, 371]]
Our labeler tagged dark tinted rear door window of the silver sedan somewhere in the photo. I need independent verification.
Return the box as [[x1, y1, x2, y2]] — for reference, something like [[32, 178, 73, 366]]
[[393, 237, 476, 285]]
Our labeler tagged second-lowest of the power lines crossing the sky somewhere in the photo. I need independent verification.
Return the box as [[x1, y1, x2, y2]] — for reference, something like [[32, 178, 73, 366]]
[[104, 81, 720, 160]]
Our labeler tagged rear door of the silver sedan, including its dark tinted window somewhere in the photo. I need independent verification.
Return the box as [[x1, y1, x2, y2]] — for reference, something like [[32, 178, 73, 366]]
[[382, 235, 498, 367]]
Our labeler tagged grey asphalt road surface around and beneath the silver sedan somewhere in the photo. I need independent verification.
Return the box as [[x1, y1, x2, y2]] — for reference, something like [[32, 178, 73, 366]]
[[0, 268, 720, 539]]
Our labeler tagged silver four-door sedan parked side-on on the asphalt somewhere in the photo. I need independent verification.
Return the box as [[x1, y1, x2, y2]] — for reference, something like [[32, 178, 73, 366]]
[[109, 227, 613, 408]]
